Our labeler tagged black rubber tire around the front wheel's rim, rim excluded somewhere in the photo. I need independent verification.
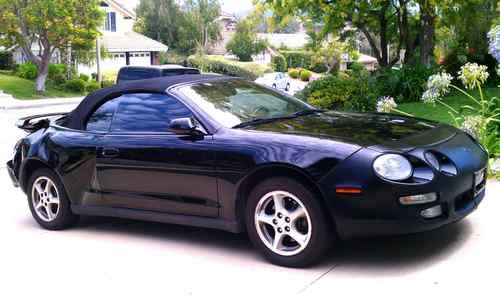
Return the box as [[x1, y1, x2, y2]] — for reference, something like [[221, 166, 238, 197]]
[[245, 177, 336, 267]]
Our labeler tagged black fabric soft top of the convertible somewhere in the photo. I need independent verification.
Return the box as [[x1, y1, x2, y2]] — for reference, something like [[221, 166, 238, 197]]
[[67, 75, 229, 130]]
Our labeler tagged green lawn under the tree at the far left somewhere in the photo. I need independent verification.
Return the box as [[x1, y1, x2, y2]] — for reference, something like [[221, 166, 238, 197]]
[[0, 71, 83, 99]]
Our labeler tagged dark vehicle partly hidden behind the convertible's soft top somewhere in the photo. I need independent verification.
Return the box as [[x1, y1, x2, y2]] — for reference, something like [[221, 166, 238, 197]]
[[116, 65, 200, 84]]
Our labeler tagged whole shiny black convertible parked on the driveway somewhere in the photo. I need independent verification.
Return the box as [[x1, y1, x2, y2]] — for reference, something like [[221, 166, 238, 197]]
[[8, 75, 487, 267]]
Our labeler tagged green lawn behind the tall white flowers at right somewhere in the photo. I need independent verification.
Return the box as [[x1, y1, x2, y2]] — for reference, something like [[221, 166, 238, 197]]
[[398, 87, 500, 124]]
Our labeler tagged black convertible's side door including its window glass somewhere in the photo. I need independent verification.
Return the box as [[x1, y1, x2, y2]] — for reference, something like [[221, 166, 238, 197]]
[[85, 93, 219, 217]]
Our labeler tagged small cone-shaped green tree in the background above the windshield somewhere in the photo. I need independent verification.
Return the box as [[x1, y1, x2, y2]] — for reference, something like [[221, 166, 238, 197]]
[[226, 19, 267, 61]]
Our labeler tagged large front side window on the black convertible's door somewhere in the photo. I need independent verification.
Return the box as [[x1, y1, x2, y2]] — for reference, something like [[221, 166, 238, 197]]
[[111, 93, 192, 133]]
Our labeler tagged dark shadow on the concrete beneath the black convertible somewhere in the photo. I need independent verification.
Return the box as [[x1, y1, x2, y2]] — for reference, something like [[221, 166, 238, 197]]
[[69, 217, 473, 275]]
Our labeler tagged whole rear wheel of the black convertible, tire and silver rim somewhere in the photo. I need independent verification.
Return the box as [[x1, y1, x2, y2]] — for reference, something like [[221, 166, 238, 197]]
[[27, 168, 78, 230]]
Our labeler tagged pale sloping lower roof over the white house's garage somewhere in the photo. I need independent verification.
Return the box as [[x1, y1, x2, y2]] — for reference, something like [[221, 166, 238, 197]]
[[102, 32, 168, 52]]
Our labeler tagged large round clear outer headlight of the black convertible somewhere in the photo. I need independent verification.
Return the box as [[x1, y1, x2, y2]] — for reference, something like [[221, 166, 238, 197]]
[[373, 154, 413, 181]]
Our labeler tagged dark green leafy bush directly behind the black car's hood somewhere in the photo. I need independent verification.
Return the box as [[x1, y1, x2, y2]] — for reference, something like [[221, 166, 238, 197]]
[[297, 71, 378, 112]]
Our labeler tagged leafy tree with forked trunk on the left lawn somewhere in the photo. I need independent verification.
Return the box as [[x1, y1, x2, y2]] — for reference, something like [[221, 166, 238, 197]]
[[0, 0, 103, 92]]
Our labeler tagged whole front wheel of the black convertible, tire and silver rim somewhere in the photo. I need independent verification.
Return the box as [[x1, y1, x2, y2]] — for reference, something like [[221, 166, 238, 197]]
[[245, 177, 335, 267]]
